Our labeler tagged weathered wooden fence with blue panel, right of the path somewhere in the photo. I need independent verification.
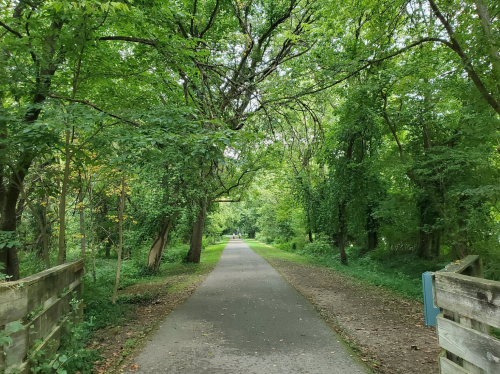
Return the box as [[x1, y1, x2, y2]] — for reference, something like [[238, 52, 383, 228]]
[[433, 256, 500, 374]]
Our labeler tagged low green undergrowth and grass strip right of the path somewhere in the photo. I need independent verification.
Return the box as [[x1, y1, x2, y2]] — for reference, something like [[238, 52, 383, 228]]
[[245, 239, 447, 302]]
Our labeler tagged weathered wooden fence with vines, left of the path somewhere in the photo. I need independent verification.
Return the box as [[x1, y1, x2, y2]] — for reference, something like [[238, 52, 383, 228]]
[[0, 260, 85, 374]]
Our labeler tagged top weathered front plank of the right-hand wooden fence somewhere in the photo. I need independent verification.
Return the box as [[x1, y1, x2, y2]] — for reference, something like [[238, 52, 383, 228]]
[[434, 272, 500, 328]]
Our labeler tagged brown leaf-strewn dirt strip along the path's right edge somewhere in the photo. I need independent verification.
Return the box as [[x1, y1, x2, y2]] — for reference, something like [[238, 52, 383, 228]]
[[265, 258, 440, 374]]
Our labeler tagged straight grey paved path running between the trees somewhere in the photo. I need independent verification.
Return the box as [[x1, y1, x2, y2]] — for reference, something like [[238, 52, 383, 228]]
[[126, 240, 370, 374]]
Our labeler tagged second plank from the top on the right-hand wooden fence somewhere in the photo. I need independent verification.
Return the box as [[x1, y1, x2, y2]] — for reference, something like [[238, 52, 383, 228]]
[[437, 315, 500, 374]]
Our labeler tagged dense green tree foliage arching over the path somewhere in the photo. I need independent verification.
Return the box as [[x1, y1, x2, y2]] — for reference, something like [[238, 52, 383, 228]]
[[0, 0, 500, 284]]
